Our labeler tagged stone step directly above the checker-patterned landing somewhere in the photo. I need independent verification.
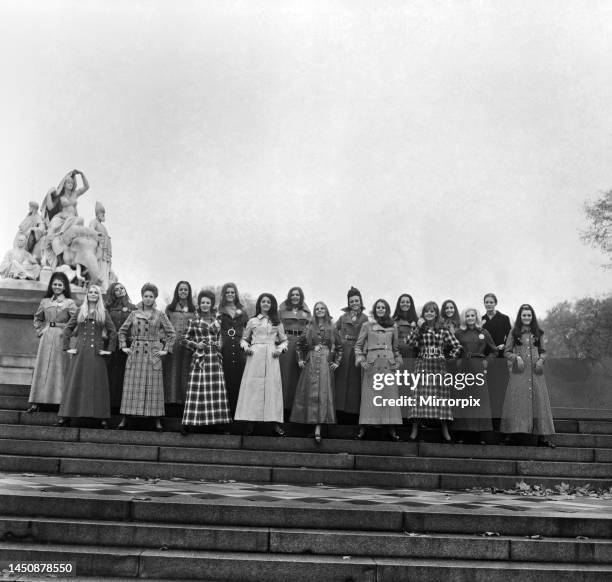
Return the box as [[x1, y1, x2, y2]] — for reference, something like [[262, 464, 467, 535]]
[[0, 454, 612, 491]]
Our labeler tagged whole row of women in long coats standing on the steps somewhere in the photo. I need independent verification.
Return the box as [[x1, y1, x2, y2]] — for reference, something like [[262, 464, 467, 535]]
[[29, 273, 554, 446]]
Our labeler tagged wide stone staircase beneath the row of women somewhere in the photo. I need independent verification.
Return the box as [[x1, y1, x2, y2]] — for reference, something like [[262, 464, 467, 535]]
[[0, 355, 612, 582]]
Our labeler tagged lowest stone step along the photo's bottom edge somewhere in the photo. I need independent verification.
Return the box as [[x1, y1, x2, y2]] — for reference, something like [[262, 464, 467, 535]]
[[0, 542, 612, 582]]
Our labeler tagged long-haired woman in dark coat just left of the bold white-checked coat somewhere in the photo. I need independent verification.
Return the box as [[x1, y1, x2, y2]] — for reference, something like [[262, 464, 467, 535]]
[[164, 281, 196, 404]]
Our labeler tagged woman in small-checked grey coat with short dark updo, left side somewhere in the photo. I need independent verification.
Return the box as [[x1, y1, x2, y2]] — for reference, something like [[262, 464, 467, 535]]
[[117, 283, 176, 431]]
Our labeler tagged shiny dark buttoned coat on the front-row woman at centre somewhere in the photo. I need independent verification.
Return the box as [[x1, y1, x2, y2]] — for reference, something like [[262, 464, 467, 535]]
[[291, 324, 342, 424]]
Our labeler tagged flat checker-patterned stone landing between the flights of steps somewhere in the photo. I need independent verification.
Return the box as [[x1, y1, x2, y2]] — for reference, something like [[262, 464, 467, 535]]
[[0, 472, 612, 525]]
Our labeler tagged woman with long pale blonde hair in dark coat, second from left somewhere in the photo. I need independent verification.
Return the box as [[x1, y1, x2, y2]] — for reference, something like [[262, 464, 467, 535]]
[[57, 285, 117, 428]]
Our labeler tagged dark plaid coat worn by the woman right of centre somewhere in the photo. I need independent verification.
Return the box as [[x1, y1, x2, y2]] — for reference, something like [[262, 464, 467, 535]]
[[408, 326, 461, 420]]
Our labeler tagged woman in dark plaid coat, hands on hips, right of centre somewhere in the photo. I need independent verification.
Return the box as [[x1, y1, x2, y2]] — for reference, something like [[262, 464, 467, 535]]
[[408, 301, 461, 443]]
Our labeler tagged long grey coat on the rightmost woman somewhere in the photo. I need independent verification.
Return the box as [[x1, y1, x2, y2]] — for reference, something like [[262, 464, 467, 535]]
[[500, 331, 555, 436]]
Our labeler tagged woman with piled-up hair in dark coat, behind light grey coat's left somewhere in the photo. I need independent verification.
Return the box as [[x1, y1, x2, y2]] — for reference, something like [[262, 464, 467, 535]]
[[334, 287, 368, 424]]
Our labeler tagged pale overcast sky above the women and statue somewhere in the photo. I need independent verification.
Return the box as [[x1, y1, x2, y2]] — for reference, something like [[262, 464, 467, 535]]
[[0, 0, 612, 315]]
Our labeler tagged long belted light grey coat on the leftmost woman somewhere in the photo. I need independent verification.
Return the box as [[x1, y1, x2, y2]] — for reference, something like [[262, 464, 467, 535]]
[[28, 295, 77, 404]]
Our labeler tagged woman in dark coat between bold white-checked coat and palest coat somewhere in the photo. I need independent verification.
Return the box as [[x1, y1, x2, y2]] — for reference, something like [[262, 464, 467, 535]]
[[218, 283, 249, 417]]
